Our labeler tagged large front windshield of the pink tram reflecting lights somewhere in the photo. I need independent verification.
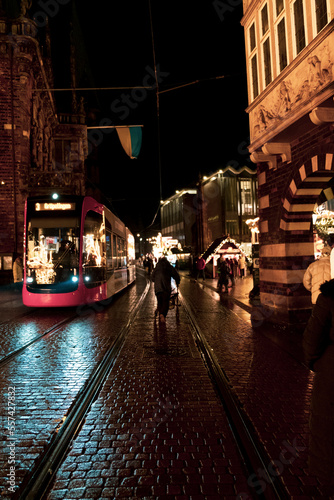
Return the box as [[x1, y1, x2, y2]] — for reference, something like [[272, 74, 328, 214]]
[[26, 217, 79, 285]]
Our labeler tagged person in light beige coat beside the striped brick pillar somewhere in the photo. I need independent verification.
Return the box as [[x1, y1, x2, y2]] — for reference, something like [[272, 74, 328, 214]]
[[303, 245, 331, 305]]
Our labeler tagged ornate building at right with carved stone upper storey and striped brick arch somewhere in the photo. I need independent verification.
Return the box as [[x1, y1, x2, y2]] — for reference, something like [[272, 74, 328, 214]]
[[242, 0, 334, 318]]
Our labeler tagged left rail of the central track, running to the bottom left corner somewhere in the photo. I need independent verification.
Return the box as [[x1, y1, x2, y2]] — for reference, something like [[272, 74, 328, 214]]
[[13, 280, 150, 500]]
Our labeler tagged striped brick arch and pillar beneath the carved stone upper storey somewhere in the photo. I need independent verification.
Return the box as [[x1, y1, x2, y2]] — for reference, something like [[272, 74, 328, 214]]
[[259, 151, 334, 321]]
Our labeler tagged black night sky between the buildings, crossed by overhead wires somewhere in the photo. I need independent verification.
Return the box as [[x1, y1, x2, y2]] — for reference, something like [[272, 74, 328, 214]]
[[47, 0, 252, 232]]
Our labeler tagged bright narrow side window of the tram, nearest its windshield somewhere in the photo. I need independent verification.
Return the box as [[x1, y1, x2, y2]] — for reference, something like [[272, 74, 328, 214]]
[[82, 211, 106, 287]]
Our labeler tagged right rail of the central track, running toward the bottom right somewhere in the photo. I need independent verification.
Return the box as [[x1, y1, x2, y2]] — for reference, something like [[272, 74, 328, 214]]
[[180, 293, 289, 500]]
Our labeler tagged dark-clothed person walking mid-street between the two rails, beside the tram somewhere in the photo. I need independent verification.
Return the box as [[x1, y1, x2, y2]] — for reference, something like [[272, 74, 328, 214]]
[[152, 257, 180, 323]]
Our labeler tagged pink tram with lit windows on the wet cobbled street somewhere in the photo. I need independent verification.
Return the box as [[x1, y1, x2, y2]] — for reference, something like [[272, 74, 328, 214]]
[[22, 194, 136, 307]]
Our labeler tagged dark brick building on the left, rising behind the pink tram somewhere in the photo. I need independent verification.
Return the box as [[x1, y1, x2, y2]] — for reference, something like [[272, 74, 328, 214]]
[[0, 6, 88, 281]]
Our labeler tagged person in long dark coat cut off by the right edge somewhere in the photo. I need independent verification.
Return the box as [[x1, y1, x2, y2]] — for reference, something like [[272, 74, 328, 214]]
[[303, 279, 334, 485]]
